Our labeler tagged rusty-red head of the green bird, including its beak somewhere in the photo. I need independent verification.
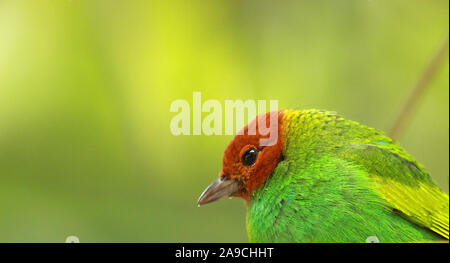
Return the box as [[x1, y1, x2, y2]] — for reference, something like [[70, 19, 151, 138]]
[[197, 111, 282, 205]]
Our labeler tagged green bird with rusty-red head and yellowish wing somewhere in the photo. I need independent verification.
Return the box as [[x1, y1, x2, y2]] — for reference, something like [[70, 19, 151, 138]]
[[197, 109, 449, 243]]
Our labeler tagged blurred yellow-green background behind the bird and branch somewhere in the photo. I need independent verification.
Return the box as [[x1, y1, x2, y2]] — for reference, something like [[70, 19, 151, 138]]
[[0, 0, 449, 242]]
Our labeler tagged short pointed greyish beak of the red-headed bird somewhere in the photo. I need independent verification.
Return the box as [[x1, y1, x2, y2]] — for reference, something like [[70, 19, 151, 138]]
[[197, 177, 239, 206]]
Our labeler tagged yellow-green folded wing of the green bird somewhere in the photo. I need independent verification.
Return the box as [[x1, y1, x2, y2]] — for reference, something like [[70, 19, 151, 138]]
[[339, 144, 449, 239]]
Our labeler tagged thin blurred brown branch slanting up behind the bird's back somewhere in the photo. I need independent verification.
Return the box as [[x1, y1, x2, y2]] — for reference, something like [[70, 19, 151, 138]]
[[389, 33, 449, 139]]
